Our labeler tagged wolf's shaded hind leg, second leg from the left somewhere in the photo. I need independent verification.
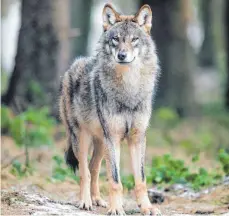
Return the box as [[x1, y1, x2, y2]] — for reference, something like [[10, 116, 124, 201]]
[[89, 138, 107, 207]]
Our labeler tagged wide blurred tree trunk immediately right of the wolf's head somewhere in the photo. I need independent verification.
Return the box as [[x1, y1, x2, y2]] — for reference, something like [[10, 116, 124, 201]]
[[142, 0, 195, 116]]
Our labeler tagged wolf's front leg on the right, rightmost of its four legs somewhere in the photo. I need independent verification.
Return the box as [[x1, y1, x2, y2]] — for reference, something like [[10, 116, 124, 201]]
[[128, 128, 159, 215]]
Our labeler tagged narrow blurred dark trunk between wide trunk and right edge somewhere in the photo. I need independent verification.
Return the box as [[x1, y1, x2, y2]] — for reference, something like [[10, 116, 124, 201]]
[[199, 0, 216, 67]]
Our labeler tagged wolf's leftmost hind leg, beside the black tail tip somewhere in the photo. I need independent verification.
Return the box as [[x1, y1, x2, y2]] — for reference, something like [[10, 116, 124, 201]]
[[73, 130, 92, 210]]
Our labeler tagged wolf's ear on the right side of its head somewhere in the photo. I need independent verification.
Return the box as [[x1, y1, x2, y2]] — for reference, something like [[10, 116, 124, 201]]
[[134, 5, 152, 34]]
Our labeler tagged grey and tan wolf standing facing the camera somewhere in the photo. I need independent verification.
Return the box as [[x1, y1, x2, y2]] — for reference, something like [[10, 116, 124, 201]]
[[59, 4, 159, 215]]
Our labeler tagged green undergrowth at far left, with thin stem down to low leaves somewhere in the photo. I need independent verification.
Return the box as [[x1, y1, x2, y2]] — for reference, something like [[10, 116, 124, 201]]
[[1, 106, 56, 177]]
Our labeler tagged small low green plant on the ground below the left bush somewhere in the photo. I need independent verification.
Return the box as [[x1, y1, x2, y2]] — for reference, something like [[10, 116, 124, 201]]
[[10, 160, 34, 178]]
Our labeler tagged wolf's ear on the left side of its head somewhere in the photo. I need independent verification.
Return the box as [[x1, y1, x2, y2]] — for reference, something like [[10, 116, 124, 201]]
[[103, 4, 120, 31]]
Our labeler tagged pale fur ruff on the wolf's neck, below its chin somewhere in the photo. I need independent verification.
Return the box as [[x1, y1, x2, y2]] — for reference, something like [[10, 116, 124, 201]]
[[100, 61, 153, 107]]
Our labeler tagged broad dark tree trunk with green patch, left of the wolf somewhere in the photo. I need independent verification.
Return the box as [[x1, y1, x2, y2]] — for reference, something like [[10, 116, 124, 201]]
[[3, 0, 59, 115]]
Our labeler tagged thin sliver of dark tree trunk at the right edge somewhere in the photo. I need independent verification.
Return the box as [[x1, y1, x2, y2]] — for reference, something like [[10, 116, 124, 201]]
[[225, 0, 229, 110]]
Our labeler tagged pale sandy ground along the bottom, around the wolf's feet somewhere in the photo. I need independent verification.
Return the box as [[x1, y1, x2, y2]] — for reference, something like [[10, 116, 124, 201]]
[[1, 182, 229, 216]]
